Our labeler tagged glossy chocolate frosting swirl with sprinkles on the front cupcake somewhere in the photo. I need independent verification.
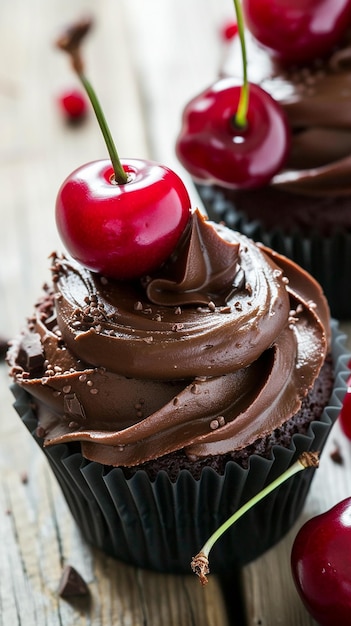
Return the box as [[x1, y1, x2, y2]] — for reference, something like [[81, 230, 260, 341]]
[[8, 212, 329, 466]]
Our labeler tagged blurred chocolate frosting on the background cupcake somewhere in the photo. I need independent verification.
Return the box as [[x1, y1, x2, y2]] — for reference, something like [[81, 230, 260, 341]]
[[222, 33, 351, 197]]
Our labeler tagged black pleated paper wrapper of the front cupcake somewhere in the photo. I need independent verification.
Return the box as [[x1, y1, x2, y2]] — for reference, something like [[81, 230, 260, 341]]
[[13, 322, 350, 573]]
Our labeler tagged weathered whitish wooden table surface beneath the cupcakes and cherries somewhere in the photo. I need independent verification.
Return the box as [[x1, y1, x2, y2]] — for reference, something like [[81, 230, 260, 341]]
[[0, 0, 351, 626]]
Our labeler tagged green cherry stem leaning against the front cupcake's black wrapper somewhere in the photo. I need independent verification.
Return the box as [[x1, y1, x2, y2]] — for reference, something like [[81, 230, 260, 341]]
[[191, 452, 319, 586]]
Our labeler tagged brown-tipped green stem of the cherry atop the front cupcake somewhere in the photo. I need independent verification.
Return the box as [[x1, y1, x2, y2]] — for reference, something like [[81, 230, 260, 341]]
[[56, 19, 128, 185]]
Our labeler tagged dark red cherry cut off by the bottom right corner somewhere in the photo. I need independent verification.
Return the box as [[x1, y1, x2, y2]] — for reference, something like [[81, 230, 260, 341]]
[[291, 498, 351, 626]]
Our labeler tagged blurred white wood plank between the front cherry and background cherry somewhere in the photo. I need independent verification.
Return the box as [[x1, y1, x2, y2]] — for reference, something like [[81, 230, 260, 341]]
[[123, 0, 234, 208]]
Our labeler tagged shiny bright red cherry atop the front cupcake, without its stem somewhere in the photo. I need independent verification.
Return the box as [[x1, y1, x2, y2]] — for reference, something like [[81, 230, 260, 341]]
[[56, 159, 190, 279]]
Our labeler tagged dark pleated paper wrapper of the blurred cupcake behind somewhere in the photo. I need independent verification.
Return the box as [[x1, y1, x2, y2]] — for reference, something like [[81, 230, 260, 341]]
[[197, 180, 351, 319]]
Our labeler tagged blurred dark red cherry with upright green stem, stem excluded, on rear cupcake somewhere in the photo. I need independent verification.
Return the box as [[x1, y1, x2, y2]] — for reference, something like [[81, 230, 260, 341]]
[[176, 78, 290, 189]]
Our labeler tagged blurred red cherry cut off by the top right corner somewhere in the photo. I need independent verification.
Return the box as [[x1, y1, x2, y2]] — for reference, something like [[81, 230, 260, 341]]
[[242, 0, 351, 63]]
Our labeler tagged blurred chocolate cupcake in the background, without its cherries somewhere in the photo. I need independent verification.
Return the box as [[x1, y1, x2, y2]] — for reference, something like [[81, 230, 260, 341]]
[[179, 25, 351, 319]]
